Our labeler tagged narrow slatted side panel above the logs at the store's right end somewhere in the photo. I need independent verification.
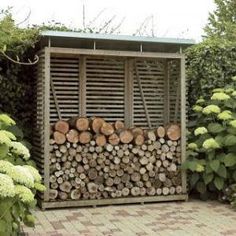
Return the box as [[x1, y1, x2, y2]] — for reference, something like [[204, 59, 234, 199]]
[[168, 60, 181, 123]]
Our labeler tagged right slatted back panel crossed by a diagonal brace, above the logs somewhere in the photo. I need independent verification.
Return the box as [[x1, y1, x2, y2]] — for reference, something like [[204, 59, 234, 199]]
[[133, 59, 165, 128]]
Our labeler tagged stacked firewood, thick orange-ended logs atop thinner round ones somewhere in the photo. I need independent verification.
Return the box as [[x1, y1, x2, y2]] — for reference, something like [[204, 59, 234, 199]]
[[50, 117, 182, 201]]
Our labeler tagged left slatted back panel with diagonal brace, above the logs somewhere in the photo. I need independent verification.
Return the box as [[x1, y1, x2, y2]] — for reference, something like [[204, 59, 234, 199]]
[[50, 57, 79, 124]]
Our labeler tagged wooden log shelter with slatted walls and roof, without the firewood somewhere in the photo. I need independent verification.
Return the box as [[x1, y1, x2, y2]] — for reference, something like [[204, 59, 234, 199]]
[[33, 31, 194, 208]]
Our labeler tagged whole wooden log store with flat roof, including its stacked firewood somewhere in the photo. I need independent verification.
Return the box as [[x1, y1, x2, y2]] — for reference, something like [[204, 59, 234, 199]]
[[33, 31, 194, 209]]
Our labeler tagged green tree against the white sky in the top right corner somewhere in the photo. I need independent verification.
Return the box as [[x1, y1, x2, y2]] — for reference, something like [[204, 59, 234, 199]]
[[205, 0, 236, 41]]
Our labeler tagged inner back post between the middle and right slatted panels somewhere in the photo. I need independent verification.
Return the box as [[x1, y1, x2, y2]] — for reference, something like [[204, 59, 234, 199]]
[[124, 59, 134, 127]]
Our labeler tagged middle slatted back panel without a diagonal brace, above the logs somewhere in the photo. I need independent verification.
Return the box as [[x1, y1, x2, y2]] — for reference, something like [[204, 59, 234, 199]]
[[86, 57, 125, 122]]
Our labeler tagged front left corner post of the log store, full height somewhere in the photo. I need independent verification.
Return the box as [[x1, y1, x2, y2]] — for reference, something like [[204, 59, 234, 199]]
[[42, 47, 50, 201]]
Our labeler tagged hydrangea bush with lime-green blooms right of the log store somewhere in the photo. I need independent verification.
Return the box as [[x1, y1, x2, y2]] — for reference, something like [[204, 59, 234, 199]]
[[183, 77, 236, 205]]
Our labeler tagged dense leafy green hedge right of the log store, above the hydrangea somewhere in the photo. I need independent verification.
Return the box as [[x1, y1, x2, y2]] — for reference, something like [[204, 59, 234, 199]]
[[186, 40, 236, 107]]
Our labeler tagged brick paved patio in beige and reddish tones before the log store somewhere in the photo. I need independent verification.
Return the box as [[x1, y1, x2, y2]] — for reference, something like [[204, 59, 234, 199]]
[[23, 200, 236, 236]]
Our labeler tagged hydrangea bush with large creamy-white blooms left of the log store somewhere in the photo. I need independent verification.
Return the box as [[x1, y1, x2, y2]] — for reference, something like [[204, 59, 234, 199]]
[[0, 114, 45, 236]]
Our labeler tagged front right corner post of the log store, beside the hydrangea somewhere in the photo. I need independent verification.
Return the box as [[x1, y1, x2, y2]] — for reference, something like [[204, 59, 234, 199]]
[[180, 56, 187, 193]]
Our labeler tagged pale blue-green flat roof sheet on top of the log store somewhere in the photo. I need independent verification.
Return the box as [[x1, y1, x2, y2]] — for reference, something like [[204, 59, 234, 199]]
[[41, 30, 195, 45]]
